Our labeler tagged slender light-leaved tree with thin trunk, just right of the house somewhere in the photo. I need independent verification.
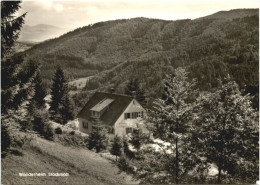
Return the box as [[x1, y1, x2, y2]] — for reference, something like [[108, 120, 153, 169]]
[[150, 68, 197, 184]]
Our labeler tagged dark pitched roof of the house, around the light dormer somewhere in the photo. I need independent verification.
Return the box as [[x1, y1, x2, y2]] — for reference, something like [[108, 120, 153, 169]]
[[77, 92, 133, 126]]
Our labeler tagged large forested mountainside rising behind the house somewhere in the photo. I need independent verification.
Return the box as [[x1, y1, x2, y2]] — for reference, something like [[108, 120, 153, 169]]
[[24, 9, 259, 110]]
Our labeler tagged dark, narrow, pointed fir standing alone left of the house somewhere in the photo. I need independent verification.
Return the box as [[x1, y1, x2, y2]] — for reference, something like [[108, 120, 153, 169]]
[[50, 66, 74, 124]]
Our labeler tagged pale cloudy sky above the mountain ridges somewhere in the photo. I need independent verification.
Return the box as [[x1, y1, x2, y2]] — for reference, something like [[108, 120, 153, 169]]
[[19, 0, 259, 28]]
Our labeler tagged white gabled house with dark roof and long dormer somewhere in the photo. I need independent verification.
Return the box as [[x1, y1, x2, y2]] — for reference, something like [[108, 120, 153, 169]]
[[77, 92, 145, 137]]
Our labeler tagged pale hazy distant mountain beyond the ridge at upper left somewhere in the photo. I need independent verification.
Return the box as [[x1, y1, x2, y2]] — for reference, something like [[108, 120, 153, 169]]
[[19, 24, 70, 42]]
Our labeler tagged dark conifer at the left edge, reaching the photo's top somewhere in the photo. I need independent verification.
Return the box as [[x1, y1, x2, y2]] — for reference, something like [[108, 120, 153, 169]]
[[1, 1, 38, 114]]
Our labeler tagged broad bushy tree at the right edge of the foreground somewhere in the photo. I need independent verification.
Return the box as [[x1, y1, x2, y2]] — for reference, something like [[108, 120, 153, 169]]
[[192, 80, 259, 184]]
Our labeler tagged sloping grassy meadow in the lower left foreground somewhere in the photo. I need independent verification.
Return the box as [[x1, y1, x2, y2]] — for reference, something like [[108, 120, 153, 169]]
[[2, 134, 138, 185]]
